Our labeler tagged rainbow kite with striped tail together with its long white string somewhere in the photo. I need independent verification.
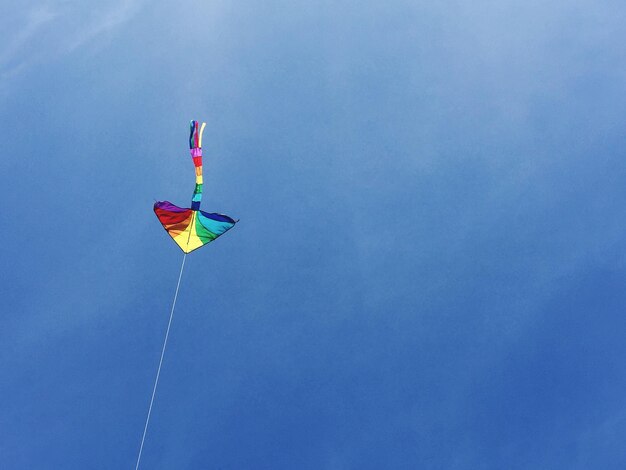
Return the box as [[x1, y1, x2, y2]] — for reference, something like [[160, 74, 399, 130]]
[[135, 121, 236, 470]]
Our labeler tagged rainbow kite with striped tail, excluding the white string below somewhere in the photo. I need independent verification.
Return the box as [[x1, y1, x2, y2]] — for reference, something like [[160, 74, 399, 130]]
[[154, 121, 236, 253]]
